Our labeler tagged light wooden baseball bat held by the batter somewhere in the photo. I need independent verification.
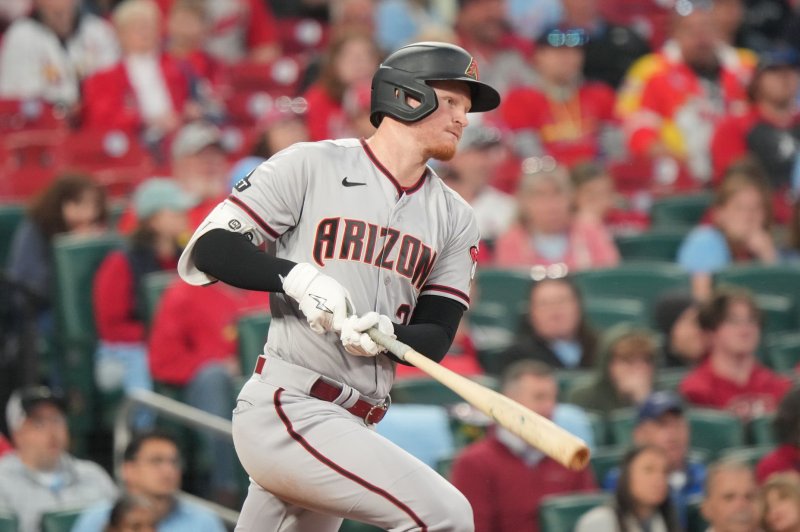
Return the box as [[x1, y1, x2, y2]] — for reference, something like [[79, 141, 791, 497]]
[[367, 327, 589, 471]]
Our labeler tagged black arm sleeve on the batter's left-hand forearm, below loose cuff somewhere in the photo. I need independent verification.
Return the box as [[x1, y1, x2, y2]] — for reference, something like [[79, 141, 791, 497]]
[[194, 229, 296, 292]]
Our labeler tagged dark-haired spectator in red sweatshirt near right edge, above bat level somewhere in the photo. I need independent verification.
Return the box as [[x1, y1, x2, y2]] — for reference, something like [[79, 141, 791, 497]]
[[680, 287, 792, 421]]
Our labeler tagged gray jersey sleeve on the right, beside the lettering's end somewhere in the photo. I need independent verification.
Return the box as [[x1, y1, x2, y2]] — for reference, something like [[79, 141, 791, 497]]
[[420, 205, 480, 309]]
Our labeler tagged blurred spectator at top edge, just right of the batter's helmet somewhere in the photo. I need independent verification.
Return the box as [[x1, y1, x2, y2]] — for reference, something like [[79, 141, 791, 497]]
[[455, 0, 536, 95]]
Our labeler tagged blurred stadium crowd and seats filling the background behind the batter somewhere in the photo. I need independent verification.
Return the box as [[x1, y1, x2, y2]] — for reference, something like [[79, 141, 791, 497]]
[[0, 0, 800, 532]]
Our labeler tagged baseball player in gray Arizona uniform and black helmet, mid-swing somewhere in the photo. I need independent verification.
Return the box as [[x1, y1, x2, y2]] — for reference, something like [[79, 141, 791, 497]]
[[178, 43, 500, 532]]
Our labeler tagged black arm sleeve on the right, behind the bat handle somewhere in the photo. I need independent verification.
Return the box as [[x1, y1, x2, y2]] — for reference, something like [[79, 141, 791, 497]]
[[392, 296, 464, 364]]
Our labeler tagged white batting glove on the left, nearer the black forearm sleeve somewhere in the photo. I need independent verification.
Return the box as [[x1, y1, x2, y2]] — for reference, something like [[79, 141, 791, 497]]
[[283, 262, 353, 334]]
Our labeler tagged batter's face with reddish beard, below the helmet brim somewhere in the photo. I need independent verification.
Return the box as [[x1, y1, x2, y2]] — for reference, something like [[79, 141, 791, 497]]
[[410, 81, 472, 161]]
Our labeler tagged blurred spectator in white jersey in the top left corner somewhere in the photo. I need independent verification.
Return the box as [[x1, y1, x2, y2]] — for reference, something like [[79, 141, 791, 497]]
[[0, 0, 119, 108]]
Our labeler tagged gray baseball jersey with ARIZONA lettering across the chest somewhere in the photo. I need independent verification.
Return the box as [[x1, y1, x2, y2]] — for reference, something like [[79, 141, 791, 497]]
[[178, 139, 479, 398]]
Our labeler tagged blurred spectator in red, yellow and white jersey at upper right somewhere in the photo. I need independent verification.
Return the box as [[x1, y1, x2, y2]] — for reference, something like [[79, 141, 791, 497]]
[[617, 0, 755, 186]]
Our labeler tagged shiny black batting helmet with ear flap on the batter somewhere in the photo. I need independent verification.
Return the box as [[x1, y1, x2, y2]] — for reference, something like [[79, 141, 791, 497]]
[[369, 42, 500, 127]]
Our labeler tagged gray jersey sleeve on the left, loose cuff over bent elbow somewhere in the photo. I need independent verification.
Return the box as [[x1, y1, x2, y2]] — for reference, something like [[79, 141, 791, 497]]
[[178, 146, 308, 285]]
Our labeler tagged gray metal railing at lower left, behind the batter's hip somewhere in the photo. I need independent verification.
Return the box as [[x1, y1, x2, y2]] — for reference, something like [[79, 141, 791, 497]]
[[114, 390, 239, 525]]
